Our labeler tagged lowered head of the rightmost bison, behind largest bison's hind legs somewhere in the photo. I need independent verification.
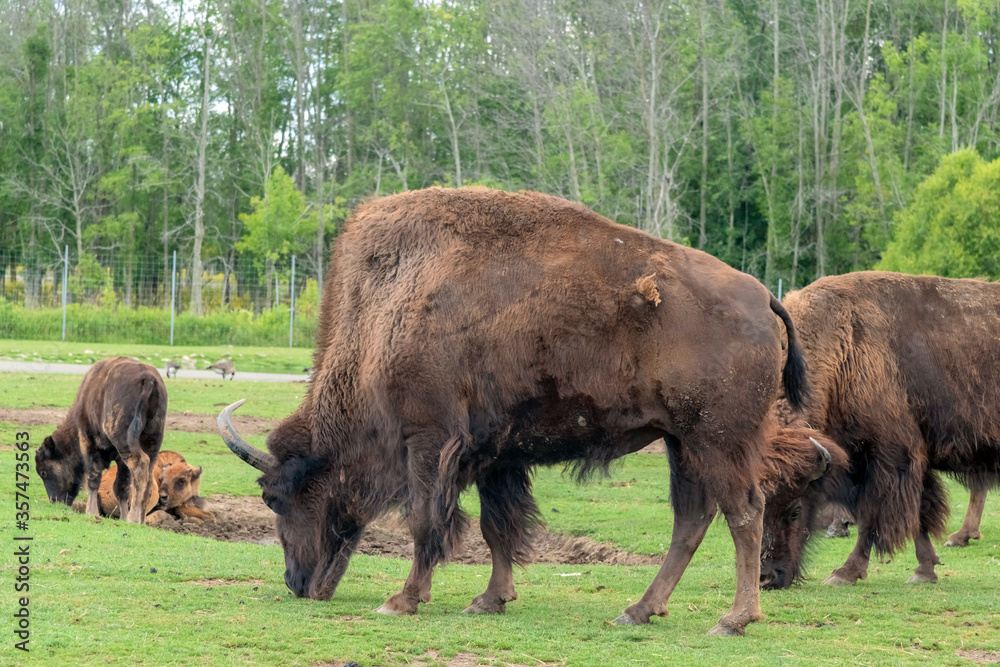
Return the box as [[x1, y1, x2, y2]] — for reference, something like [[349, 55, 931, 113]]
[[760, 428, 847, 589]]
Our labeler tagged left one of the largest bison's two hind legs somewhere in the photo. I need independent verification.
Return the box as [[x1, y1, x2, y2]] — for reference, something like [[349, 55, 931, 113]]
[[615, 468, 716, 625]]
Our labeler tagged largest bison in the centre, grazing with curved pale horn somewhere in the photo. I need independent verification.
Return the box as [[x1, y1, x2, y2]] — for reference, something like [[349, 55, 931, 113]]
[[219, 188, 832, 634]]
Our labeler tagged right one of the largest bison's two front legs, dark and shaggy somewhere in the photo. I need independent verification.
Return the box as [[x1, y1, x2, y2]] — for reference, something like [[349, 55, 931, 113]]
[[463, 468, 540, 614]]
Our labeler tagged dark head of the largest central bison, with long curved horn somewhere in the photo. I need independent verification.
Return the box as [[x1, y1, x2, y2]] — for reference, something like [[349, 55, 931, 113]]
[[219, 400, 367, 600]]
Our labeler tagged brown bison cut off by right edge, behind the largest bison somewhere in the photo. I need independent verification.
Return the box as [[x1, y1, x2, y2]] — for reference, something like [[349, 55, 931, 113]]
[[761, 272, 1000, 588]]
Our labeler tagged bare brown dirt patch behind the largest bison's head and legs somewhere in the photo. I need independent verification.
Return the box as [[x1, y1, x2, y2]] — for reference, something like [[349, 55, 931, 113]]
[[150, 496, 663, 565]]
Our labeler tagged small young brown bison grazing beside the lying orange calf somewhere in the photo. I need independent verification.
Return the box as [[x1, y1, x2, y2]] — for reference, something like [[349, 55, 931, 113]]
[[35, 357, 167, 523]]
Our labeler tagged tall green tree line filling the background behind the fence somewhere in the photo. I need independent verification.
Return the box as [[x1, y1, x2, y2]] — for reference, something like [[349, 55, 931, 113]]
[[0, 0, 1000, 313]]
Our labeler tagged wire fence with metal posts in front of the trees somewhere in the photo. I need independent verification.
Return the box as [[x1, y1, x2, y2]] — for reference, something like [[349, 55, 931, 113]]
[[0, 246, 319, 347]]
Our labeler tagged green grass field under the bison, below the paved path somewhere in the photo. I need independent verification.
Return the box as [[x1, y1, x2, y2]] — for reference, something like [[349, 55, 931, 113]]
[[0, 374, 1000, 667]]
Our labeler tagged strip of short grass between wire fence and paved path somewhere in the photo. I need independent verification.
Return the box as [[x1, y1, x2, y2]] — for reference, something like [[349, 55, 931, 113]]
[[0, 339, 312, 375]]
